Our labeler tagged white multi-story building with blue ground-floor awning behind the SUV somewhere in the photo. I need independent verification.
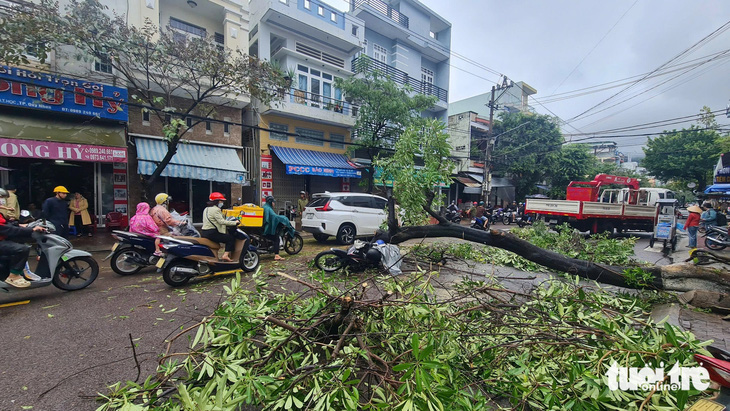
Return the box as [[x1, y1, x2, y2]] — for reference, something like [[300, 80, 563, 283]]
[[246, 0, 365, 206]]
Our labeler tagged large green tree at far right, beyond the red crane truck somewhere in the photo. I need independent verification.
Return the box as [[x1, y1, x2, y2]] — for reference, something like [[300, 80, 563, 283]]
[[641, 110, 724, 189]]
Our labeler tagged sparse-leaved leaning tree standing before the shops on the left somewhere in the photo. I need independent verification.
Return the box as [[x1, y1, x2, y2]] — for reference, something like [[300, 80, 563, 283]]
[[0, 0, 286, 200]]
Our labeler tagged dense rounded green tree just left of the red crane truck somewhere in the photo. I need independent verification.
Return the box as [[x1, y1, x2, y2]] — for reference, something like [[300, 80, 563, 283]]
[[492, 112, 563, 198]]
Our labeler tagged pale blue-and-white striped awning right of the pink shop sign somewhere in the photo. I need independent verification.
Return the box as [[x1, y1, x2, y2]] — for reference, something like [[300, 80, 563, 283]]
[[134, 137, 246, 184]]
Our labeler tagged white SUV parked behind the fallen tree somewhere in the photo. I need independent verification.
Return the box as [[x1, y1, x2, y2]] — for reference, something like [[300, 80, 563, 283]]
[[302, 192, 388, 244]]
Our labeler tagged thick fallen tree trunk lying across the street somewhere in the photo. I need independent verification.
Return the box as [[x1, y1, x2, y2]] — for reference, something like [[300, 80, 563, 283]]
[[388, 198, 730, 301]]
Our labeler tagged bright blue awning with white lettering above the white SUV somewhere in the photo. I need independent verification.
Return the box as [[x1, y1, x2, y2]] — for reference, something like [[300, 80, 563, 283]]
[[270, 146, 362, 178]]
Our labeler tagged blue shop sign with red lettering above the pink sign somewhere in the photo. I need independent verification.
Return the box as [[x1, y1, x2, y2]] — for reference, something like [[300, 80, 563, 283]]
[[0, 65, 129, 121]]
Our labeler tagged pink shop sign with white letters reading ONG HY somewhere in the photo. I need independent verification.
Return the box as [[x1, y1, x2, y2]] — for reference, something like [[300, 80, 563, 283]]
[[0, 138, 127, 163]]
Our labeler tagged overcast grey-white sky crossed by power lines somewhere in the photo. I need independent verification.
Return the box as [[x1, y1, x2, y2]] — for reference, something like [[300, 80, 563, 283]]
[[331, 0, 730, 159]]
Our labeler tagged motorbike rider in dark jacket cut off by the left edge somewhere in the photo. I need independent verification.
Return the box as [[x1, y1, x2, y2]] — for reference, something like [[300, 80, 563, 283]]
[[0, 188, 45, 288]]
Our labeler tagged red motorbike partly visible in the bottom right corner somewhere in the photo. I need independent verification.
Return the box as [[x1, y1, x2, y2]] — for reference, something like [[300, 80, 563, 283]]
[[688, 346, 730, 411]]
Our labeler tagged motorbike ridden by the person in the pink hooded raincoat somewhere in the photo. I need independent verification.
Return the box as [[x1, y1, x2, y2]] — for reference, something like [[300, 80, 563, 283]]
[[103, 230, 159, 275]]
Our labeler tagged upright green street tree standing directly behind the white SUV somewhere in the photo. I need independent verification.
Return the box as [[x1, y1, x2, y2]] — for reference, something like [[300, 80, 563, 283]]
[[335, 57, 436, 193]]
